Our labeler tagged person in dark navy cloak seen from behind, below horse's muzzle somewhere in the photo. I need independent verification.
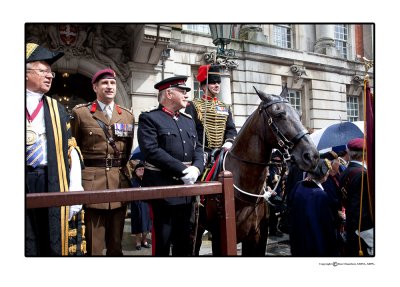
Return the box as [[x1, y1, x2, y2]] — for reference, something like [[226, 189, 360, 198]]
[[288, 159, 339, 256]]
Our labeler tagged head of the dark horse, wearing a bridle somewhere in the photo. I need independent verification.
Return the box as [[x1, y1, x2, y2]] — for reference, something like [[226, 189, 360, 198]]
[[254, 88, 319, 171]]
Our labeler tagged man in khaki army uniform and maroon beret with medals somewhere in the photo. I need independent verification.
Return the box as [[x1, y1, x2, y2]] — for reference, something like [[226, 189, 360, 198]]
[[72, 69, 135, 256]]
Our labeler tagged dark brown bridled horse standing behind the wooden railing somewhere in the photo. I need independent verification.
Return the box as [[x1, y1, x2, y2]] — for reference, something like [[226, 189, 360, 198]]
[[202, 87, 319, 256]]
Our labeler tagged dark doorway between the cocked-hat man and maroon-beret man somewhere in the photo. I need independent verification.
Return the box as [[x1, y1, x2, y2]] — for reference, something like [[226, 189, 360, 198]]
[[47, 73, 96, 113]]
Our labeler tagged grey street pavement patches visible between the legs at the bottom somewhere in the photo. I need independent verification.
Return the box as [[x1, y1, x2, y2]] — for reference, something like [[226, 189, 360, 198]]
[[122, 218, 290, 256]]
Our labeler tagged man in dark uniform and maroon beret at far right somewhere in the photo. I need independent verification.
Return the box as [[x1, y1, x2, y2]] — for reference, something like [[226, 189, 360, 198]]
[[340, 138, 375, 256]]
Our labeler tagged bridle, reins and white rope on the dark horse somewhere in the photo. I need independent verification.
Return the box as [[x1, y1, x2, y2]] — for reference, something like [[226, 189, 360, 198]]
[[223, 98, 309, 205]]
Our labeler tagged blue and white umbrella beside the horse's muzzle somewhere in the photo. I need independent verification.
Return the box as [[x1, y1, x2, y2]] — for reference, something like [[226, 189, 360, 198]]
[[311, 121, 364, 152]]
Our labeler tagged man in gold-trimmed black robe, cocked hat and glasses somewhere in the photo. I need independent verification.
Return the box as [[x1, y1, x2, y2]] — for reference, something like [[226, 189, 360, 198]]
[[25, 43, 86, 256]]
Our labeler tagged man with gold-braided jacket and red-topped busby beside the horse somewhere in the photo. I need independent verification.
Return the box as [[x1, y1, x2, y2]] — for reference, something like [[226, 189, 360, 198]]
[[186, 65, 237, 256]]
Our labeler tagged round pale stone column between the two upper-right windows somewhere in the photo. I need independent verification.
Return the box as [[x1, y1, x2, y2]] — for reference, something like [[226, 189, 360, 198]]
[[314, 24, 338, 57]]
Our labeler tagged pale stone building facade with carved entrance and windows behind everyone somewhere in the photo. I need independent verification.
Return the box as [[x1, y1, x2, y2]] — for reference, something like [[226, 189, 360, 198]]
[[25, 23, 375, 146]]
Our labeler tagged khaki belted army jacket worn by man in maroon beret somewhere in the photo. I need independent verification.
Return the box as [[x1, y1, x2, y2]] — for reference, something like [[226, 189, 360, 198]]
[[71, 101, 135, 209]]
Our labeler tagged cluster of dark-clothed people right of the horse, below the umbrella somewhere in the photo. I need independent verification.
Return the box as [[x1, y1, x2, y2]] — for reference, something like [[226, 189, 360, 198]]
[[269, 138, 374, 257]]
